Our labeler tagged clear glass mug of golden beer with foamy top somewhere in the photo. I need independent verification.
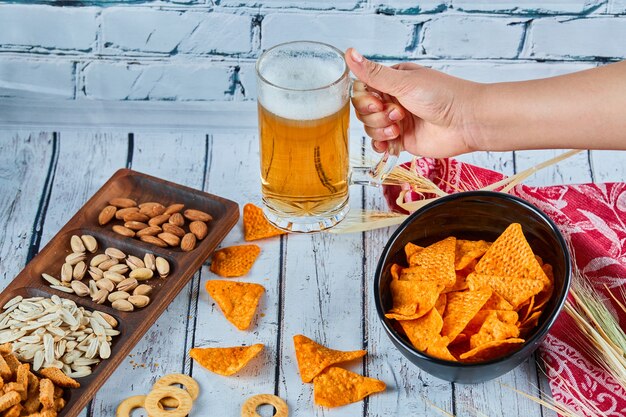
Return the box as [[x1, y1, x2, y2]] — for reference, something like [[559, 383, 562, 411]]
[[256, 41, 396, 232]]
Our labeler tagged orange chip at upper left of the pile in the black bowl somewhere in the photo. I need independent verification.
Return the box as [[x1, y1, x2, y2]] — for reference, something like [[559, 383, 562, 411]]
[[403, 237, 456, 285]]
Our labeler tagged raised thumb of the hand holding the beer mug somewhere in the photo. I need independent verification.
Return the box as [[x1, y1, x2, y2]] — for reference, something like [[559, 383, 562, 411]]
[[345, 48, 409, 97]]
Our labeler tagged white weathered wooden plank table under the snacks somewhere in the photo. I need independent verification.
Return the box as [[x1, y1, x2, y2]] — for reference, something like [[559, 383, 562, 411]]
[[0, 126, 626, 417]]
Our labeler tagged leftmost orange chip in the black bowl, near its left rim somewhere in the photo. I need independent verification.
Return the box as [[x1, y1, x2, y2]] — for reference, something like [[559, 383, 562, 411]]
[[385, 280, 443, 320]]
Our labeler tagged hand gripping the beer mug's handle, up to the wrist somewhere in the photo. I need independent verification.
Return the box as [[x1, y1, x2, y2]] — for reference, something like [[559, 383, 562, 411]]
[[345, 48, 481, 158]]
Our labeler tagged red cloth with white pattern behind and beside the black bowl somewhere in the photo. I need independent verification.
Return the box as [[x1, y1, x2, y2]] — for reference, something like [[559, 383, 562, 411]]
[[383, 158, 626, 417]]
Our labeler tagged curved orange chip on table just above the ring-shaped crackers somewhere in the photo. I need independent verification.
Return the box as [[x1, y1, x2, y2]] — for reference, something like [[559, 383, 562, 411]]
[[189, 343, 263, 376]]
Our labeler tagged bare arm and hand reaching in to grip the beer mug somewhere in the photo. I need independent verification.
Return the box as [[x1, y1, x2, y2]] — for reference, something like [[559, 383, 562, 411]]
[[346, 49, 626, 157]]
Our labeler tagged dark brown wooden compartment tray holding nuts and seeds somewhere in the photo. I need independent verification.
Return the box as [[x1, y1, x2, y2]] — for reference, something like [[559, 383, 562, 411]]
[[0, 169, 239, 417]]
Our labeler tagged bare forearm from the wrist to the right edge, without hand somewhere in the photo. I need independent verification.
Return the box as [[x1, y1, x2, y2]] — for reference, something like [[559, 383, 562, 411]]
[[473, 61, 626, 151]]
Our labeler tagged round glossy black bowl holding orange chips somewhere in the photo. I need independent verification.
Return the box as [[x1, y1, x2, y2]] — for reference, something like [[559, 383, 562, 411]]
[[374, 191, 571, 384]]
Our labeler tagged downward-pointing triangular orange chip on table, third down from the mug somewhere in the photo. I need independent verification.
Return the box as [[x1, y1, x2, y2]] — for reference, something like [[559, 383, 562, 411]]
[[206, 280, 265, 330]]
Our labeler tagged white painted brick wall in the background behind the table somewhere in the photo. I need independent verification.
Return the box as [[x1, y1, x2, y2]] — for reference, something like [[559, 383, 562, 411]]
[[0, 0, 626, 101]]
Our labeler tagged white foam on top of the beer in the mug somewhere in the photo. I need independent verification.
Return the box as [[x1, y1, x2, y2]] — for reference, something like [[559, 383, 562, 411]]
[[259, 57, 348, 120]]
